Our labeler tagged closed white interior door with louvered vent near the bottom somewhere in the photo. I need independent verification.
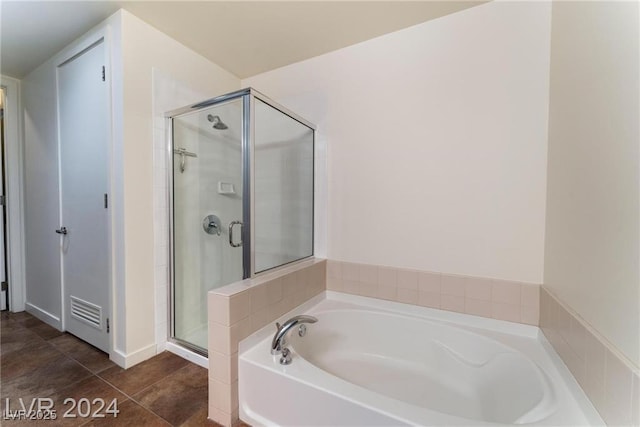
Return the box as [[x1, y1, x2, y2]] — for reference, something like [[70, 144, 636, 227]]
[[56, 42, 110, 352]]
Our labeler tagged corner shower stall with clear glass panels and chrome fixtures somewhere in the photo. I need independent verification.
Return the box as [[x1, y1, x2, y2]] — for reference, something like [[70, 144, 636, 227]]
[[166, 88, 315, 355]]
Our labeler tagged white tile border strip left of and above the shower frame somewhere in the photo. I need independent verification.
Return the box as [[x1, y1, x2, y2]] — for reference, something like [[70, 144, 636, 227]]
[[152, 68, 225, 352]]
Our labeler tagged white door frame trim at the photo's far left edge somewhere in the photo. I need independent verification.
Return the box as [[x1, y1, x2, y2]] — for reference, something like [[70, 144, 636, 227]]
[[0, 75, 26, 312]]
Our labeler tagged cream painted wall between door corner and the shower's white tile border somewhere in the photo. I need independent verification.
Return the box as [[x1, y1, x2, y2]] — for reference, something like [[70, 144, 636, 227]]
[[116, 11, 240, 360]]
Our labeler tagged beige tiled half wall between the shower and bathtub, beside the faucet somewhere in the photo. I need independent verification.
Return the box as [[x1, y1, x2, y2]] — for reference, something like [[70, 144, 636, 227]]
[[208, 259, 326, 426]]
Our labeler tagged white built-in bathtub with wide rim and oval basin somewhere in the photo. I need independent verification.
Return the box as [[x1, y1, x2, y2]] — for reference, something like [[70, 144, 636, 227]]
[[239, 292, 603, 426]]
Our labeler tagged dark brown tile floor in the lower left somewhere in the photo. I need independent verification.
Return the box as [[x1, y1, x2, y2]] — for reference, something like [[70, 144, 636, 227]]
[[0, 312, 224, 427]]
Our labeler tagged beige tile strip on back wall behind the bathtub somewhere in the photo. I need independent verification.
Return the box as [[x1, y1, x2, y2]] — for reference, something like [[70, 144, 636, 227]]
[[327, 261, 540, 325]]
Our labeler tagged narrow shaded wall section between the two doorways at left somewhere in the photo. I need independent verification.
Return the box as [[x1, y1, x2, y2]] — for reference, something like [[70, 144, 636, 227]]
[[22, 61, 62, 326]]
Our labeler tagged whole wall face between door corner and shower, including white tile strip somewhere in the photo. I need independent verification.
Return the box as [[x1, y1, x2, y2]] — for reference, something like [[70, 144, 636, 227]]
[[117, 10, 239, 366]]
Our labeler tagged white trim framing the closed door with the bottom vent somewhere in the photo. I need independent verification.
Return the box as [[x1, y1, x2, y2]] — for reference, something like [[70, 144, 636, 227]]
[[56, 28, 117, 358]]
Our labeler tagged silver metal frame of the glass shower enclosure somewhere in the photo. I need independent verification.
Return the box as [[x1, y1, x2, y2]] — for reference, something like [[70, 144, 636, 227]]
[[165, 87, 316, 355]]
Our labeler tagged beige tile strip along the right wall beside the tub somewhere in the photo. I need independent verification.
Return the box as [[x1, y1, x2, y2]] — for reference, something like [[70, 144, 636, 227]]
[[540, 286, 640, 426]]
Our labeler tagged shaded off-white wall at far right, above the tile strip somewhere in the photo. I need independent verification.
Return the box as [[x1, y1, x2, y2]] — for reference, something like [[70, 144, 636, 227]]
[[544, 2, 640, 366]]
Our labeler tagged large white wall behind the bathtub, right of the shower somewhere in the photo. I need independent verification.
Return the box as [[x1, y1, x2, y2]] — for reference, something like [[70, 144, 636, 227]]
[[242, 2, 550, 283]]
